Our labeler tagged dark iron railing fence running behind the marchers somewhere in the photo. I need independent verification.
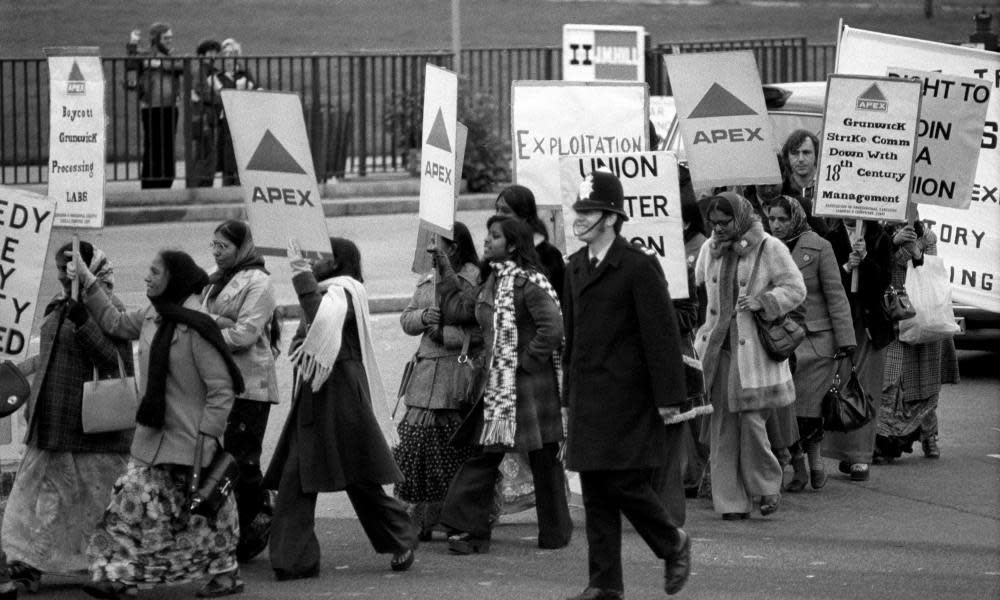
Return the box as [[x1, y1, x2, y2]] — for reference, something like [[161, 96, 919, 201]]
[[0, 38, 835, 185]]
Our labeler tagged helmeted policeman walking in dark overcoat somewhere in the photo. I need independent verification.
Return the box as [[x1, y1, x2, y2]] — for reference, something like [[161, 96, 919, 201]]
[[563, 171, 691, 600]]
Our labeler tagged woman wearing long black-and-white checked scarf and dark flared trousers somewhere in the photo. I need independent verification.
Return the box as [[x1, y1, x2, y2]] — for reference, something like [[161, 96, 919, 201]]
[[437, 215, 573, 554]]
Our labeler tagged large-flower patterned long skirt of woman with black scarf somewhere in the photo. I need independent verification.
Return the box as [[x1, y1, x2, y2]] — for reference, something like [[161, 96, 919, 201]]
[[87, 460, 239, 587]]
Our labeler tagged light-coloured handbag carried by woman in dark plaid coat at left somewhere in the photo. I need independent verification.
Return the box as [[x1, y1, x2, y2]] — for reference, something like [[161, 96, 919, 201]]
[[80, 350, 139, 433]]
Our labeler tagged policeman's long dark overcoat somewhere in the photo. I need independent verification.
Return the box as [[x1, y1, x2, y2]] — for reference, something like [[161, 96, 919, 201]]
[[563, 236, 687, 471]]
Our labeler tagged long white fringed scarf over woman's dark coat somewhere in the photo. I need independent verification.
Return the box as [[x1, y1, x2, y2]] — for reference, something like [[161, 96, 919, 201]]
[[289, 276, 398, 446]]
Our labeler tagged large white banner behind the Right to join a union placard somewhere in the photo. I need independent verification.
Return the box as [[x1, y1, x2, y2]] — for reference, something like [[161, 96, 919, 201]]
[[837, 27, 1000, 312]]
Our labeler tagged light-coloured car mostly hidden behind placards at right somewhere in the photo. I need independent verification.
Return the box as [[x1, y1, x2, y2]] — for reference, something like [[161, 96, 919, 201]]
[[661, 81, 1000, 352]]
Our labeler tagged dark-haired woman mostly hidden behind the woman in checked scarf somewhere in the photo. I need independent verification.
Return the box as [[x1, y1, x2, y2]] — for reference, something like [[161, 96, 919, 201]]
[[492, 185, 566, 519]]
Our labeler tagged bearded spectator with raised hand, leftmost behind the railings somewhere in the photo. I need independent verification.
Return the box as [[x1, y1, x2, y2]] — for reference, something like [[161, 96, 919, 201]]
[[125, 23, 183, 189]]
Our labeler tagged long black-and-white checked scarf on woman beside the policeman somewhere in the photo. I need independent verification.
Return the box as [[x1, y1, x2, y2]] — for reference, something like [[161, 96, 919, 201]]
[[480, 260, 562, 448]]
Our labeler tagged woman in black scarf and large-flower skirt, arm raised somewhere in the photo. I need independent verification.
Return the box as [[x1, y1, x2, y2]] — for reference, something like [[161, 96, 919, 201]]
[[75, 250, 243, 599]]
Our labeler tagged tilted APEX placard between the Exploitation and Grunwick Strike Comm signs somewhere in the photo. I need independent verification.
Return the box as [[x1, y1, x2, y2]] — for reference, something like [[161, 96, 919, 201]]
[[663, 51, 781, 188]]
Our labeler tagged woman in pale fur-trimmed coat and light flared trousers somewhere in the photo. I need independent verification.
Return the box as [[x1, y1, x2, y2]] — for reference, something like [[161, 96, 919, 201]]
[[695, 192, 806, 520]]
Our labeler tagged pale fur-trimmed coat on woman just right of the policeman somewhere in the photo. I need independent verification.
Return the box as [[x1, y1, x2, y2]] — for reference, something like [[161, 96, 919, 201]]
[[695, 222, 806, 412]]
